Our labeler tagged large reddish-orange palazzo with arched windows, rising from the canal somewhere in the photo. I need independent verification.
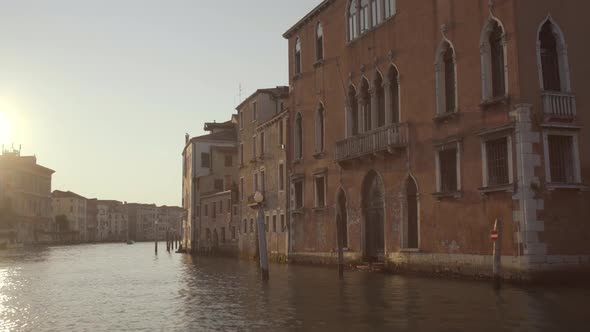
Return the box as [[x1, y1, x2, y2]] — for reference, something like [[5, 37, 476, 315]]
[[284, 0, 590, 277]]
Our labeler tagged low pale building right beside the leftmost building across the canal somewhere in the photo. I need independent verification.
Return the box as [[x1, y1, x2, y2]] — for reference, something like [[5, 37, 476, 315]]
[[51, 190, 88, 242]]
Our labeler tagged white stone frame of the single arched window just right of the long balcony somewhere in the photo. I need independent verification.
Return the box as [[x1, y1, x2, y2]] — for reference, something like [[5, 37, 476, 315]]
[[434, 33, 459, 116]]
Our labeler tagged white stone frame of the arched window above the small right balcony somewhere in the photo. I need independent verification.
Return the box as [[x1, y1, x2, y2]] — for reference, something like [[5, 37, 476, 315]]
[[535, 15, 572, 93]]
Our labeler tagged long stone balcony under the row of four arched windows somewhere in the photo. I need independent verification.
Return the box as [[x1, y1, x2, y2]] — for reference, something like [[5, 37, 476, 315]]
[[336, 123, 409, 162]]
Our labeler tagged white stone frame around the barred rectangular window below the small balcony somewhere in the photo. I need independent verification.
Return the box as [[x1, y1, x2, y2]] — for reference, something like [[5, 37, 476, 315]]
[[543, 128, 585, 190]]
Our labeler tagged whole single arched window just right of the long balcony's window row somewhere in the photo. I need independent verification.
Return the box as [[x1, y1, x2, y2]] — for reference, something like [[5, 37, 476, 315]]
[[436, 40, 457, 115]]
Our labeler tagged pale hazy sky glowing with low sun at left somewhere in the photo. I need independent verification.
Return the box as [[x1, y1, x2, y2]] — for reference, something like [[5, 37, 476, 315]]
[[0, 0, 321, 205]]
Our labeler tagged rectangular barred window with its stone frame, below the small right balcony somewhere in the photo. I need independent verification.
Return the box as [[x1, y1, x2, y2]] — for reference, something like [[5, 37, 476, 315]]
[[543, 131, 582, 184]]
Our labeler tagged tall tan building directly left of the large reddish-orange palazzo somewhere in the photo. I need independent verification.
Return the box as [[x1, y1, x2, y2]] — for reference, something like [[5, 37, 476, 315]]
[[236, 87, 289, 258]]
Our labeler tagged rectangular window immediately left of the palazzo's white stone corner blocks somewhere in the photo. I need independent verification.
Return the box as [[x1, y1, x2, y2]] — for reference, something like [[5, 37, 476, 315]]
[[483, 137, 512, 187]]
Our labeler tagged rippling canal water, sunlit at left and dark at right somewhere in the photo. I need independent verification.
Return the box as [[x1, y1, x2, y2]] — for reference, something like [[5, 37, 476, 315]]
[[0, 243, 590, 331]]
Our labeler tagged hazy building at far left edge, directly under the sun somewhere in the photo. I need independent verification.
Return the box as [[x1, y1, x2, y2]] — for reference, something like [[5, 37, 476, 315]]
[[0, 149, 54, 246]]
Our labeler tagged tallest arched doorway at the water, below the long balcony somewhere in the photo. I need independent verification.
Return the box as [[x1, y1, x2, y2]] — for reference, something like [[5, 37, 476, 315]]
[[363, 171, 385, 261]]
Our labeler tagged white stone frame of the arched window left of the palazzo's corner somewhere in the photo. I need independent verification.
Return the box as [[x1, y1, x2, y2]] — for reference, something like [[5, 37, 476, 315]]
[[479, 14, 510, 104]]
